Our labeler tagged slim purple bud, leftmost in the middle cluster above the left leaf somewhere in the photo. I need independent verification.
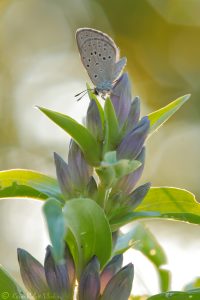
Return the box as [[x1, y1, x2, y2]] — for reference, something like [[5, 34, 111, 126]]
[[54, 153, 73, 197]]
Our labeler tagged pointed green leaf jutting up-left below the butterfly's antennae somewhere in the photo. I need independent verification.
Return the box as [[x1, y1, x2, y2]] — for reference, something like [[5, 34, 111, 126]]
[[38, 107, 100, 166]]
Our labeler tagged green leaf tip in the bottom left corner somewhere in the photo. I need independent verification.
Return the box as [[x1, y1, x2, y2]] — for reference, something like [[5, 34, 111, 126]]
[[0, 265, 28, 300]]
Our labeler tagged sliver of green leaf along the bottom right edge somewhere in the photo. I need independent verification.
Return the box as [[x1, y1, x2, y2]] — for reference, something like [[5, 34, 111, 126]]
[[147, 289, 200, 300]]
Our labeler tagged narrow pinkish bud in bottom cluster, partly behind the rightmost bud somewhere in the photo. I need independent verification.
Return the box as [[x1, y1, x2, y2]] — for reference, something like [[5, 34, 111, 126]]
[[100, 254, 123, 294]]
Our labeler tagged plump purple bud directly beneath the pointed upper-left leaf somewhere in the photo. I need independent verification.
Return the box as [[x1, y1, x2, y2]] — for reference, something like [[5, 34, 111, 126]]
[[68, 140, 92, 190]]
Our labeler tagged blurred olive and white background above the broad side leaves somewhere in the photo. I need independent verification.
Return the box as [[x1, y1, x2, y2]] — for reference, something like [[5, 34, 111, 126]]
[[0, 0, 200, 296]]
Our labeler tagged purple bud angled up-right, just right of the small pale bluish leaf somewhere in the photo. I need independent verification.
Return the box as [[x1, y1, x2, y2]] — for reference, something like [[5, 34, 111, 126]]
[[117, 147, 145, 195]]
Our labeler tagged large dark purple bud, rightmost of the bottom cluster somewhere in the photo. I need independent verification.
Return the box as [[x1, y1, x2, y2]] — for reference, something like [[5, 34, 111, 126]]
[[101, 263, 134, 300]]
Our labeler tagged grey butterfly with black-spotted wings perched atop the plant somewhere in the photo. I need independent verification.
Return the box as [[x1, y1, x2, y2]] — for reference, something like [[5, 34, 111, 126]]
[[76, 28, 127, 97]]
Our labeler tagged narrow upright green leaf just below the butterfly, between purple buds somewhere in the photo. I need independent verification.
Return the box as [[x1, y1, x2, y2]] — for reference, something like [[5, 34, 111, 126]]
[[104, 98, 119, 153]]
